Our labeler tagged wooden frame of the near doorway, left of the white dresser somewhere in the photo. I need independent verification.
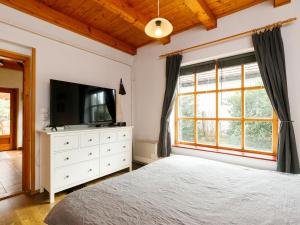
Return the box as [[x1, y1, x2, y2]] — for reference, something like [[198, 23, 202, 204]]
[[0, 48, 36, 192]]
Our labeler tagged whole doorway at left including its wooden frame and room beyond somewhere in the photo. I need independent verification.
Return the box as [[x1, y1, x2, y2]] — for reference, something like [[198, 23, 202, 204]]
[[0, 49, 35, 200]]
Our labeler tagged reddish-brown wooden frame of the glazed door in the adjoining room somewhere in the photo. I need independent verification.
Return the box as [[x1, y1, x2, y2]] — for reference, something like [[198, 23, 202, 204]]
[[0, 87, 19, 152]]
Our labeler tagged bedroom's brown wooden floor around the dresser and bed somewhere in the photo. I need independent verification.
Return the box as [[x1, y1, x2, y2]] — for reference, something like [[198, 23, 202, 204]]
[[0, 165, 140, 225]]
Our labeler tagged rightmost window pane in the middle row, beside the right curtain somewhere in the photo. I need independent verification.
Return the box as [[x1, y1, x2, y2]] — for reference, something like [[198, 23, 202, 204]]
[[245, 89, 273, 118]]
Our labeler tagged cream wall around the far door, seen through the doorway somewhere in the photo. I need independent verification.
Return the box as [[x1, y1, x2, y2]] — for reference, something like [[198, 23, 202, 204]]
[[0, 67, 23, 147]]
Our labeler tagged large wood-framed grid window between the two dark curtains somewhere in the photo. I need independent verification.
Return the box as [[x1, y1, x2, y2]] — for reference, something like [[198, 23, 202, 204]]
[[175, 53, 278, 155]]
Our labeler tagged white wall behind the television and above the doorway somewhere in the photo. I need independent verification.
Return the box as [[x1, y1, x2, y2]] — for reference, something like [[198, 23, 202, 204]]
[[0, 4, 133, 188]]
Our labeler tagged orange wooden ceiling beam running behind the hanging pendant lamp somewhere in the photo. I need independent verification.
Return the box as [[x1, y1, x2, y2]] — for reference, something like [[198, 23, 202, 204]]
[[93, 0, 170, 44]]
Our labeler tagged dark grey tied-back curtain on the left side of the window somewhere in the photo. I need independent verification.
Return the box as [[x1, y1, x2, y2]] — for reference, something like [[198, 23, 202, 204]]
[[158, 55, 182, 157]]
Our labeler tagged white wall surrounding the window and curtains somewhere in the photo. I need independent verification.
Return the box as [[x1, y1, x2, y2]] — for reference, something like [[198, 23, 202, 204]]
[[133, 0, 300, 169]]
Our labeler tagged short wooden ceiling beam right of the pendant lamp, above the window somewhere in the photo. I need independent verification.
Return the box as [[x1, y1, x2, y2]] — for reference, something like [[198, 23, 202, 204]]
[[184, 0, 217, 30]]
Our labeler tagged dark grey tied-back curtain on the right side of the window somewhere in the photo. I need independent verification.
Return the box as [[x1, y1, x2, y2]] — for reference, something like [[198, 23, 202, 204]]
[[252, 28, 300, 173]]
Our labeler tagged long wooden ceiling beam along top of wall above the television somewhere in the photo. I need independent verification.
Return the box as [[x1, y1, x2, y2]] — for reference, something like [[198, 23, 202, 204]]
[[0, 0, 136, 55]]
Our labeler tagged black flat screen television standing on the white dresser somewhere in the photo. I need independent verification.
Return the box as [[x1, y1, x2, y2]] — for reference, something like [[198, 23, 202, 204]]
[[50, 80, 116, 127]]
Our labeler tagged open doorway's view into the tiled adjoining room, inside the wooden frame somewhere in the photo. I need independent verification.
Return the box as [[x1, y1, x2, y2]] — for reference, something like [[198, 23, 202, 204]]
[[0, 58, 23, 198]]
